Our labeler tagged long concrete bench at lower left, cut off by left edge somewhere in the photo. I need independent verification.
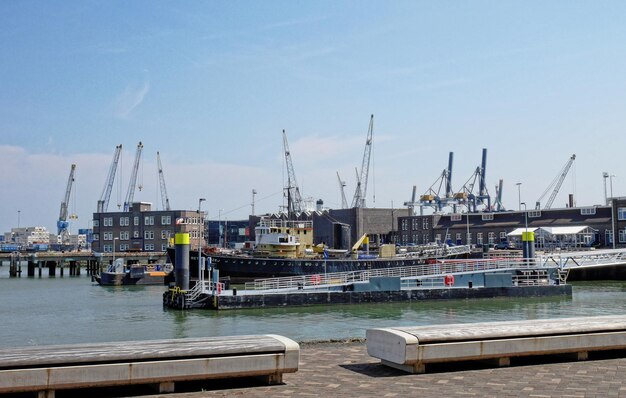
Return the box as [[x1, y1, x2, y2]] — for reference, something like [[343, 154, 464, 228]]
[[0, 335, 300, 398]]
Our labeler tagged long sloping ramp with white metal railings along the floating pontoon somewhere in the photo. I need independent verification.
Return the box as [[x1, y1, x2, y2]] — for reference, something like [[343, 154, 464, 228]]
[[245, 255, 557, 291]]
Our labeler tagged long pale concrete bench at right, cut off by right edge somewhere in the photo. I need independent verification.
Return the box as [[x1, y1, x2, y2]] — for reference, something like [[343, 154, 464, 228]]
[[366, 316, 626, 373]]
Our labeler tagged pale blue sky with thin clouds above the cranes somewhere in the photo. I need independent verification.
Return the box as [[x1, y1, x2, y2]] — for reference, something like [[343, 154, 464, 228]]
[[0, 0, 626, 232]]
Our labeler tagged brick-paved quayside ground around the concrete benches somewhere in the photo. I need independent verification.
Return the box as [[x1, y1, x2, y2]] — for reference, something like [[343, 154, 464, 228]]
[[132, 342, 626, 398]]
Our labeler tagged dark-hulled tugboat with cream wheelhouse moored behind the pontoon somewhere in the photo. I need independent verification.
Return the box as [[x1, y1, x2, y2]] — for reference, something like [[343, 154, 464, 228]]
[[168, 219, 470, 282]]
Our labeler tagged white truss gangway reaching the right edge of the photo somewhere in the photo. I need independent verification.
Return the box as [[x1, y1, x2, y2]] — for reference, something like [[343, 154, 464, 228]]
[[536, 249, 626, 270]]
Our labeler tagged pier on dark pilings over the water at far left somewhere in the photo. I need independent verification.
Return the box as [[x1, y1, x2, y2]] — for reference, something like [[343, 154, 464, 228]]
[[0, 251, 167, 278]]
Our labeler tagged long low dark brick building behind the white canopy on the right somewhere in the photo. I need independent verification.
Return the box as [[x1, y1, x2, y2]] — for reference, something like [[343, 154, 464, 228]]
[[397, 198, 626, 249]]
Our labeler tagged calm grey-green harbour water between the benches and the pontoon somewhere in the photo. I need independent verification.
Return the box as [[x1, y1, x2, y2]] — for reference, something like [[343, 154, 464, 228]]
[[0, 266, 626, 346]]
